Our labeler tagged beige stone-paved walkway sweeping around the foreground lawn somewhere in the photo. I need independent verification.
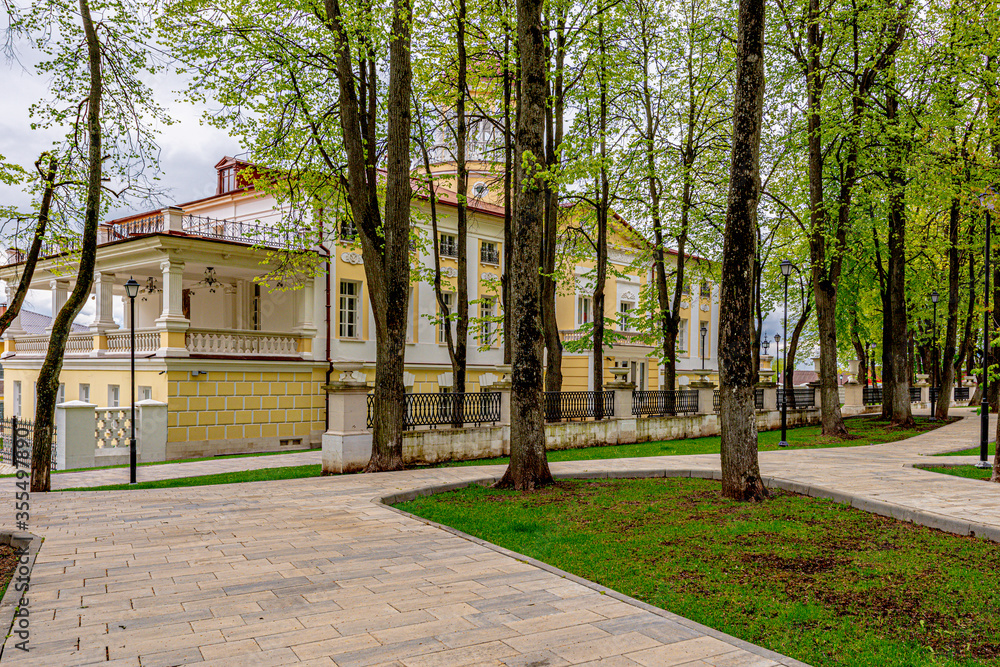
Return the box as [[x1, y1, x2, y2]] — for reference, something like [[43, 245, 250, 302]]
[[0, 410, 1000, 667]]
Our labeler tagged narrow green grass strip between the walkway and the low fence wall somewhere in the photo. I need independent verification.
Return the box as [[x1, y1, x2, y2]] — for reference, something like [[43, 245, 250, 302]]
[[440, 416, 955, 466]]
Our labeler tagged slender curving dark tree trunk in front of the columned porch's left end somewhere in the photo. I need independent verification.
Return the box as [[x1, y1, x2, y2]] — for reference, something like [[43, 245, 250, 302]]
[[31, 0, 104, 492]]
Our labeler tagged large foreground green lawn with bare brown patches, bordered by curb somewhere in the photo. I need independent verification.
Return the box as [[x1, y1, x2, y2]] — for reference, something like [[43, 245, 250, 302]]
[[397, 478, 1000, 667]]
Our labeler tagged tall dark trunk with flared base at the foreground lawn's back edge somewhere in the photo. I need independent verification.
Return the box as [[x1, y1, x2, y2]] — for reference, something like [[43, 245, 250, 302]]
[[497, 0, 552, 491]]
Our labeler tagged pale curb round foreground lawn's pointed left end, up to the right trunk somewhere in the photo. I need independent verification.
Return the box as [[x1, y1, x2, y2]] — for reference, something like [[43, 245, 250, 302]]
[[372, 468, 810, 667]]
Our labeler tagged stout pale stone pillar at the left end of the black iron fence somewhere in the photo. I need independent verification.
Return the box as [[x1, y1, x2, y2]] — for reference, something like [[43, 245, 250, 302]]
[[323, 372, 372, 475]]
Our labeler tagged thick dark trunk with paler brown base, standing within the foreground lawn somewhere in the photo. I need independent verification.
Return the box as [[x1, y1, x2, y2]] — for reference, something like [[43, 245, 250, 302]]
[[719, 0, 767, 501]]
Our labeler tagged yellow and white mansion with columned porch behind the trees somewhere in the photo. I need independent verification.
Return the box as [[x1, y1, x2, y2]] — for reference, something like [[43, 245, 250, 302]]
[[0, 158, 718, 459]]
